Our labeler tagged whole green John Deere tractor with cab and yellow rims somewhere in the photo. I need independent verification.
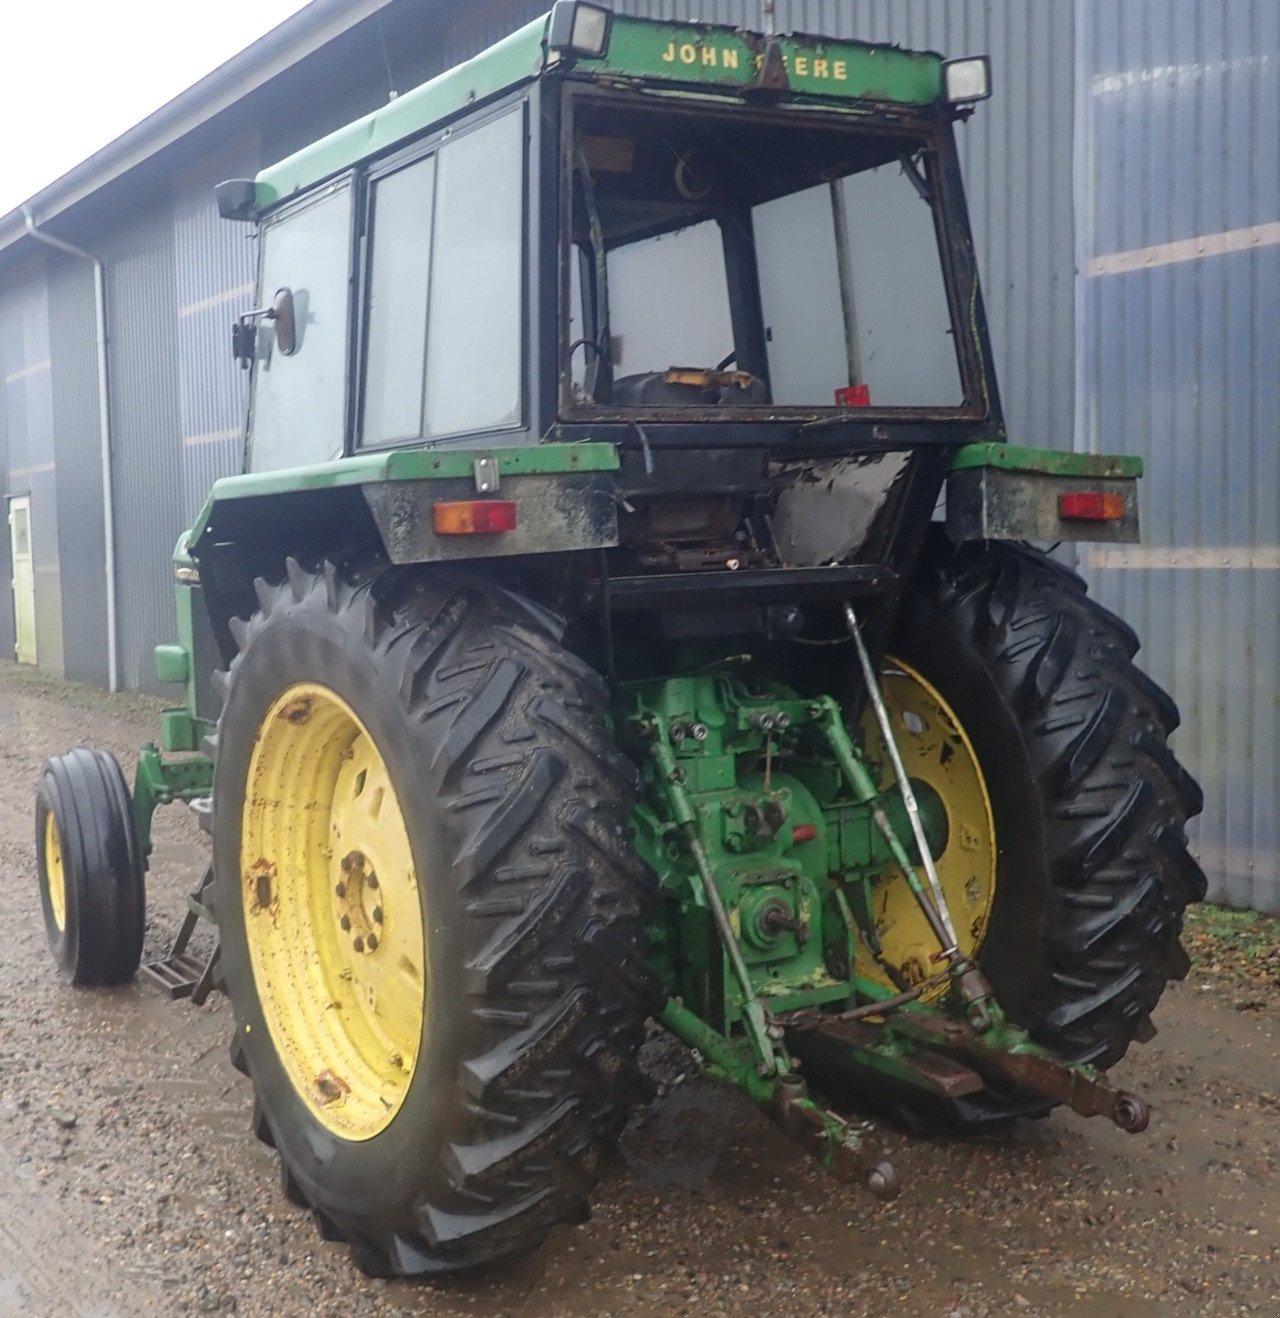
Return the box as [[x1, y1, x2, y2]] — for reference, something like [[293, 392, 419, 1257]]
[[37, 0, 1205, 1276]]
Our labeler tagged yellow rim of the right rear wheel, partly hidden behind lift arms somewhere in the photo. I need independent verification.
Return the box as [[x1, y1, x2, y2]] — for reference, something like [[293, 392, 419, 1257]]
[[857, 656, 997, 999]]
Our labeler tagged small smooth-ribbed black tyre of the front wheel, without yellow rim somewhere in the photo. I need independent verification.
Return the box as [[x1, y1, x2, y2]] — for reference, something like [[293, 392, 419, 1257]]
[[36, 746, 146, 986]]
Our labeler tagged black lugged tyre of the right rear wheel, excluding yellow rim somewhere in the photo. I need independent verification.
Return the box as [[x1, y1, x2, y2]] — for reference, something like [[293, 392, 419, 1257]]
[[811, 542, 1205, 1131]]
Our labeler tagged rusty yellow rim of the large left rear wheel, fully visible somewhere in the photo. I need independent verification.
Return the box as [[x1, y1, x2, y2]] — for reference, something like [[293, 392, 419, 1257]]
[[240, 683, 430, 1140]]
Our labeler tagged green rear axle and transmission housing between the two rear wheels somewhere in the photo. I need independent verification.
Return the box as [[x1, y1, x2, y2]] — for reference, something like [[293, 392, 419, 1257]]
[[624, 670, 946, 1036]]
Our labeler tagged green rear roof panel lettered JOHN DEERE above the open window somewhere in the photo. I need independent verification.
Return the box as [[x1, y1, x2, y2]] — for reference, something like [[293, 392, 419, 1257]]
[[590, 14, 943, 105]]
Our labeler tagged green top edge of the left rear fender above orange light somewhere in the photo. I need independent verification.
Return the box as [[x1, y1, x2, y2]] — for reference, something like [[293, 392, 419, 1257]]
[[179, 443, 621, 545]]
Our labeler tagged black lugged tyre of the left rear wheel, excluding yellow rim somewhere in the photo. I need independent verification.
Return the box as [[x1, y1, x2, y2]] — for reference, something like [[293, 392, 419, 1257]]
[[214, 561, 654, 1276]]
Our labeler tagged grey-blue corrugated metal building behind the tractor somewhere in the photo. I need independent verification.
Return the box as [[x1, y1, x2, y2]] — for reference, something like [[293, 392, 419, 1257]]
[[0, 0, 1280, 909]]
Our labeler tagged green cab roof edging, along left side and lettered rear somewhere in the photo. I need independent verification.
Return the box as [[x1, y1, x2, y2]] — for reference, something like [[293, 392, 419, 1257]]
[[256, 14, 943, 211]]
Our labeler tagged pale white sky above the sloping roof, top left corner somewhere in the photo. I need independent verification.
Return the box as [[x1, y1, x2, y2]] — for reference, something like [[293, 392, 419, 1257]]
[[0, 0, 316, 219]]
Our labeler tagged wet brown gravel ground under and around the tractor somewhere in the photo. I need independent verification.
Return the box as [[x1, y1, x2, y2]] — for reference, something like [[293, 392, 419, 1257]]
[[0, 664, 1280, 1318]]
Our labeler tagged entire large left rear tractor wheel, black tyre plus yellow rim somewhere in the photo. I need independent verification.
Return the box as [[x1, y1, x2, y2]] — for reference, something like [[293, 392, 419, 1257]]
[[214, 563, 647, 1276]]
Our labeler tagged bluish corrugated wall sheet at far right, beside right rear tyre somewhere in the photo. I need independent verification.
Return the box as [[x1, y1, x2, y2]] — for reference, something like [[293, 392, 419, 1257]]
[[1077, 0, 1280, 909]]
